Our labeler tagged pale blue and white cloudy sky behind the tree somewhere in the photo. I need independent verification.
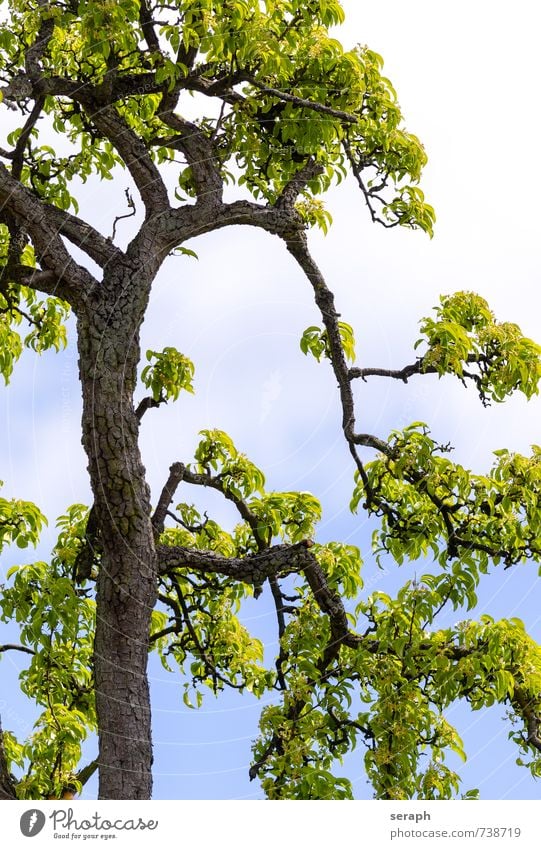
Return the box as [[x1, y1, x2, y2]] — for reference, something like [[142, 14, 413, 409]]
[[0, 0, 541, 798]]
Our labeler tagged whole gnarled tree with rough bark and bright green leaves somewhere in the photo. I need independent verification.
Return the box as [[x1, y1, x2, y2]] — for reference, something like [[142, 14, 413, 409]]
[[0, 0, 541, 799]]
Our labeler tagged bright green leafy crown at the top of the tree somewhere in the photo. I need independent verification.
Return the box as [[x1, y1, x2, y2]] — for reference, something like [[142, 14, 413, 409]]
[[0, 0, 434, 225]]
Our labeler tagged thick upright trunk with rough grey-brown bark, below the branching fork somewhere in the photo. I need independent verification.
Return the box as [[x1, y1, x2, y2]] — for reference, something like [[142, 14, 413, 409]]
[[78, 266, 157, 799]]
